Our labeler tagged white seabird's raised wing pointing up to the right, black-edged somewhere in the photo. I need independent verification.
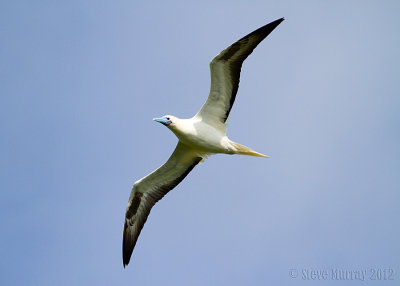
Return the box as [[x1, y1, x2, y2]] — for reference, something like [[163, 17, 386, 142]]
[[196, 18, 284, 130]]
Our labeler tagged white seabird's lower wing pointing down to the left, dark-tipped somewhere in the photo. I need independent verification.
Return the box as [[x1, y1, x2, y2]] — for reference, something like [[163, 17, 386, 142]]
[[122, 142, 205, 267]]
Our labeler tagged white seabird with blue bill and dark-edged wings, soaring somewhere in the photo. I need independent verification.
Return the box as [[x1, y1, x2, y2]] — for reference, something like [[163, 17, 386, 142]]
[[122, 18, 284, 268]]
